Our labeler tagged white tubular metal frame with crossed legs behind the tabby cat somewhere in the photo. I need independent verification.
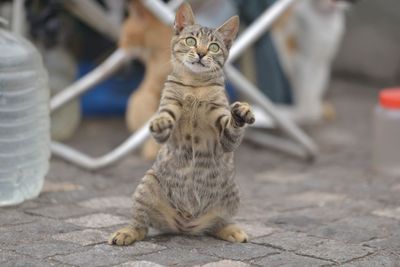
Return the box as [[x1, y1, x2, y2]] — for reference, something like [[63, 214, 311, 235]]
[[50, 0, 317, 170]]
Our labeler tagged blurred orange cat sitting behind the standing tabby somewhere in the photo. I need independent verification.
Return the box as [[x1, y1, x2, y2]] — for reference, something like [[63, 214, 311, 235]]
[[119, 0, 172, 160]]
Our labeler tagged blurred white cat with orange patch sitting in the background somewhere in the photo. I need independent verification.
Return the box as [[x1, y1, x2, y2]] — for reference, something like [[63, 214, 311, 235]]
[[272, 0, 349, 124]]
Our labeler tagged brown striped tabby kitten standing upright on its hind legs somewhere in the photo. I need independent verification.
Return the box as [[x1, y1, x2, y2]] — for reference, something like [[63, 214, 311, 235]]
[[109, 3, 254, 245]]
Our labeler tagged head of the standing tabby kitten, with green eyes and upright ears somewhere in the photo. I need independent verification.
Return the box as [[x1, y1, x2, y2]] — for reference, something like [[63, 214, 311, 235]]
[[172, 4, 239, 73]]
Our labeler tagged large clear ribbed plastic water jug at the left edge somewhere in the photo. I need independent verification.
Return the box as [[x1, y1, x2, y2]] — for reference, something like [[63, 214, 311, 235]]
[[0, 23, 50, 206]]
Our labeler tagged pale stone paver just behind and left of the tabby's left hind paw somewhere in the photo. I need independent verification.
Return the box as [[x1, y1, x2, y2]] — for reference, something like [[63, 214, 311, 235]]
[[66, 213, 129, 228]]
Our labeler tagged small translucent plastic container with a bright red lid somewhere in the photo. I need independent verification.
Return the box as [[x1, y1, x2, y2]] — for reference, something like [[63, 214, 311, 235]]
[[373, 88, 400, 177]]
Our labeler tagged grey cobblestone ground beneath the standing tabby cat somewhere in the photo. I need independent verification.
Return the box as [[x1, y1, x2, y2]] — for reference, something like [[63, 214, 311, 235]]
[[0, 78, 400, 267]]
